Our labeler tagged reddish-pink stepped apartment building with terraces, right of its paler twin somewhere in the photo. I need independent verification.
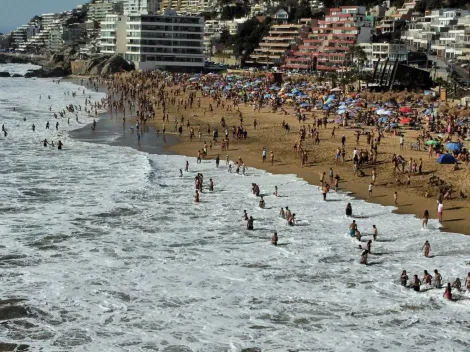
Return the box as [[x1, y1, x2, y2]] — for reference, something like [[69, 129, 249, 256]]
[[284, 6, 373, 71]]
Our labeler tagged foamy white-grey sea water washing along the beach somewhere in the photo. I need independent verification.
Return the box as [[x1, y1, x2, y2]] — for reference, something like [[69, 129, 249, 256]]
[[0, 67, 470, 352]]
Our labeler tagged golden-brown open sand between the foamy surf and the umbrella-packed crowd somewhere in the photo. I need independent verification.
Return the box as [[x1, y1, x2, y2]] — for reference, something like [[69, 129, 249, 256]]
[[140, 85, 470, 234]]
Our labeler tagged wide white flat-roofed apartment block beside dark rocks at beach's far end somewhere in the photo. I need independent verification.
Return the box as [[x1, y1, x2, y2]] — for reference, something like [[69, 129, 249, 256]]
[[100, 10, 204, 71]]
